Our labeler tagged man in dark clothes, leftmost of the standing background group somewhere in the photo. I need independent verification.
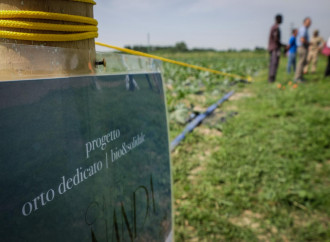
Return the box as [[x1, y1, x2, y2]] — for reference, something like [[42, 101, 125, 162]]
[[268, 14, 285, 82]]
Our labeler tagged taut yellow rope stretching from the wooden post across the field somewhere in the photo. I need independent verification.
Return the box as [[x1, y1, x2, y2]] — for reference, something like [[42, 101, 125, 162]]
[[95, 42, 252, 81]]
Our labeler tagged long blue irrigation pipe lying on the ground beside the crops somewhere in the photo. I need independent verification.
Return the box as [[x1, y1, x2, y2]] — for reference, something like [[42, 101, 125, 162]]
[[170, 91, 234, 151]]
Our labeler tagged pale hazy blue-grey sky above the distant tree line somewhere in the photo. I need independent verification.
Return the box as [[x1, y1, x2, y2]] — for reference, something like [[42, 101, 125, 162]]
[[94, 0, 330, 50]]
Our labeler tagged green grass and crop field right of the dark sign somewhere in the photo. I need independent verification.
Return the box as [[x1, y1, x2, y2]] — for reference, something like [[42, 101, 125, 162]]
[[164, 53, 330, 241]]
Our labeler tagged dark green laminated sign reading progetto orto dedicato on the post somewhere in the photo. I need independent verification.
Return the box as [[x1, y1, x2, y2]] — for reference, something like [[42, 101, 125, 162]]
[[0, 73, 172, 242]]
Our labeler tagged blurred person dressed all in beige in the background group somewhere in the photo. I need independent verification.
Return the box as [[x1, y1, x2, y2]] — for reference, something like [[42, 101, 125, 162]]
[[304, 30, 325, 74]]
